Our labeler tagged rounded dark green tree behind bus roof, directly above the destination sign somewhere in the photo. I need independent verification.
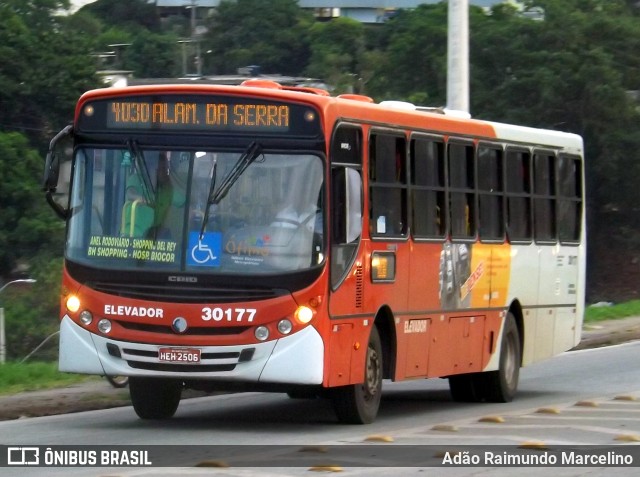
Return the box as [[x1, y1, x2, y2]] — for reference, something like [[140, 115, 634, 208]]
[[202, 0, 314, 75]]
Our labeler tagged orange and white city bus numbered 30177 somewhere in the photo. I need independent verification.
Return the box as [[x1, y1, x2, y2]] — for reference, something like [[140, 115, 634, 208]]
[[45, 80, 585, 423]]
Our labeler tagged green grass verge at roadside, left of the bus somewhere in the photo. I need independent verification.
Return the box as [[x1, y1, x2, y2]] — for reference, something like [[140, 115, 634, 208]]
[[0, 362, 96, 395]]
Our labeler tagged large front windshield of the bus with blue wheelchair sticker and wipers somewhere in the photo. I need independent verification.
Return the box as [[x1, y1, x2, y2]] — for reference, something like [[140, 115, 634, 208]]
[[66, 142, 324, 275]]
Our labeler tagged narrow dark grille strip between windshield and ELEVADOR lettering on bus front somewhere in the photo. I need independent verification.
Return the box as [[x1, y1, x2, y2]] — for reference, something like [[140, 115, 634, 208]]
[[87, 282, 288, 303]]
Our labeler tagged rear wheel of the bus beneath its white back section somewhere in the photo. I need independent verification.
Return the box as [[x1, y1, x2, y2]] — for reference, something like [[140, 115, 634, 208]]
[[476, 313, 522, 402]]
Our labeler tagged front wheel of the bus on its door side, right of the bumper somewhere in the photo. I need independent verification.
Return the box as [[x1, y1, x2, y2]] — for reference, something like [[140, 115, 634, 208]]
[[331, 326, 383, 424]]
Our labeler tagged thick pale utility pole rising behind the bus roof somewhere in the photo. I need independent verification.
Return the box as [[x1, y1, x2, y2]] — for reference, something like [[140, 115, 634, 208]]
[[447, 0, 469, 113]]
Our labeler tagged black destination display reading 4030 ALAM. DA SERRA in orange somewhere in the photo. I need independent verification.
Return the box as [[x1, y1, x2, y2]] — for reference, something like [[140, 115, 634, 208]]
[[77, 95, 320, 136]]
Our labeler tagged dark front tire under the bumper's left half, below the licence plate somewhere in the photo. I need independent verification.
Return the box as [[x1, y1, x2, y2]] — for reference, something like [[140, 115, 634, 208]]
[[129, 377, 182, 419]]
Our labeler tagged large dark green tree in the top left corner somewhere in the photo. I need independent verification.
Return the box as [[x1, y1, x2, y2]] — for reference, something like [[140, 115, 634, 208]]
[[0, 0, 97, 148]]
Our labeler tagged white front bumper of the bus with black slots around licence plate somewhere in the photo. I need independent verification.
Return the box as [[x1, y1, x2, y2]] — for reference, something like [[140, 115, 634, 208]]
[[59, 315, 324, 384]]
